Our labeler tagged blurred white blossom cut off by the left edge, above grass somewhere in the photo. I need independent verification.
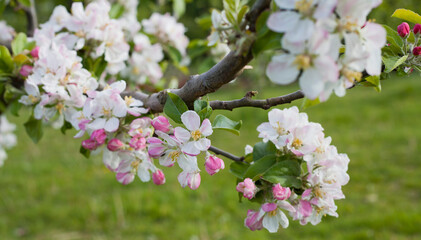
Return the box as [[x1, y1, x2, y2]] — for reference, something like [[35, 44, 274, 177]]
[[0, 116, 16, 167]]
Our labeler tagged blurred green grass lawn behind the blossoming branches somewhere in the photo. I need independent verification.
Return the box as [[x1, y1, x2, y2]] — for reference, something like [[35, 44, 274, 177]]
[[0, 74, 421, 239]]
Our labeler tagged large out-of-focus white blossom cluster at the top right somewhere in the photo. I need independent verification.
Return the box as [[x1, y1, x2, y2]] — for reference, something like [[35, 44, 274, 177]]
[[266, 0, 386, 101]]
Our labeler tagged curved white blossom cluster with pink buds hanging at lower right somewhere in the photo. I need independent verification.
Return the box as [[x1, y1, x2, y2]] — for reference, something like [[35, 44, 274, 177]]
[[237, 107, 349, 232]]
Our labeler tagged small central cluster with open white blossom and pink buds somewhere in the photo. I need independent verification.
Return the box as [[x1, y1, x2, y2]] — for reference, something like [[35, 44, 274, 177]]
[[147, 111, 225, 190]]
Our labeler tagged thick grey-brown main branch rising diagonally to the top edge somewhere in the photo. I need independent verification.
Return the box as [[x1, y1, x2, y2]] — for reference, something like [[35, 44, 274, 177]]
[[129, 0, 271, 112]]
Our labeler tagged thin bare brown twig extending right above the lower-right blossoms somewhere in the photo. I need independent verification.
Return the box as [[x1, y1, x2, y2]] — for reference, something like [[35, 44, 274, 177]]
[[210, 91, 304, 111]]
